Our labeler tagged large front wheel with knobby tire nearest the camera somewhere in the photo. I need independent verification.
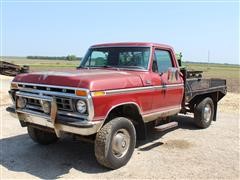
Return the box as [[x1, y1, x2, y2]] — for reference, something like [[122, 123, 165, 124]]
[[95, 117, 136, 169]]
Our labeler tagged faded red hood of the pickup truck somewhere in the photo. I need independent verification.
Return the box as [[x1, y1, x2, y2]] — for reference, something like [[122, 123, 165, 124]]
[[13, 69, 143, 91]]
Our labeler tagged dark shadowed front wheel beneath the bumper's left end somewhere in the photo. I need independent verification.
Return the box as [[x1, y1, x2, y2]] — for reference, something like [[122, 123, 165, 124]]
[[27, 126, 59, 145]]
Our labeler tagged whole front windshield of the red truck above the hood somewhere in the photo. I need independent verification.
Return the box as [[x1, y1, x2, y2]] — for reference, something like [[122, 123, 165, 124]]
[[80, 47, 150, 69]]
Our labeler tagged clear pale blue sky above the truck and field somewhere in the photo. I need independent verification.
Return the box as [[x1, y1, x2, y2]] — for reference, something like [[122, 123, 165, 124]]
[[2, 0, 240, 64]]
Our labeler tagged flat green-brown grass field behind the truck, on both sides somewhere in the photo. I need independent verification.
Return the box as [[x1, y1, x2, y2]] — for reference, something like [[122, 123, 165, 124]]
[[3, 58, 240, 93]]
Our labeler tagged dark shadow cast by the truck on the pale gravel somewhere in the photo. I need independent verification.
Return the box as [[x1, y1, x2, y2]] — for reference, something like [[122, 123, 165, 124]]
[[0, 116, 197, 179]]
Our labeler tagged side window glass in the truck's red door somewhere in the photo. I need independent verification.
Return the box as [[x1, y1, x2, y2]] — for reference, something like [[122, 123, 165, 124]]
[[155, 49, 173, 73]]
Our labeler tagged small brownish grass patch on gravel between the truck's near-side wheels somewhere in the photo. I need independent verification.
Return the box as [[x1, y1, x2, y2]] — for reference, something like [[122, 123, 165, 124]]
[[163, 139, 193, 149]]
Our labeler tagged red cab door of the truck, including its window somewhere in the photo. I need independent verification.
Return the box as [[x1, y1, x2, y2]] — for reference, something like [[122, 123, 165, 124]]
[[152, 49, 184, 113]]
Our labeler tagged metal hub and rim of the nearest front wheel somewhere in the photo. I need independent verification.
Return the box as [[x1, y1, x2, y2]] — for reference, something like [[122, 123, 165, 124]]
[[112, 129, 130, 158]]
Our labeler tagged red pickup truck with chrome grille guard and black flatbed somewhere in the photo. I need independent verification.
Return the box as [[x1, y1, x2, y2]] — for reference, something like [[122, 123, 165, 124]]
[[7, 43, 226, 169]]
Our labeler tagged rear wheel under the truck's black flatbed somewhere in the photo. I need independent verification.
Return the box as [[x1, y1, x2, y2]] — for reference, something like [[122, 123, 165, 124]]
[[194, 97, 214, 129]]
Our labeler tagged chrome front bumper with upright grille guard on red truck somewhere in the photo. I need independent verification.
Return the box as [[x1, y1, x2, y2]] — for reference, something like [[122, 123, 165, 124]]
[[6, 92, 103, 137]]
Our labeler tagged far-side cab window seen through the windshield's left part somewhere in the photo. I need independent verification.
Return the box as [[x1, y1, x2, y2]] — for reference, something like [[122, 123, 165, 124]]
[[89, 51, 108, 66]]
